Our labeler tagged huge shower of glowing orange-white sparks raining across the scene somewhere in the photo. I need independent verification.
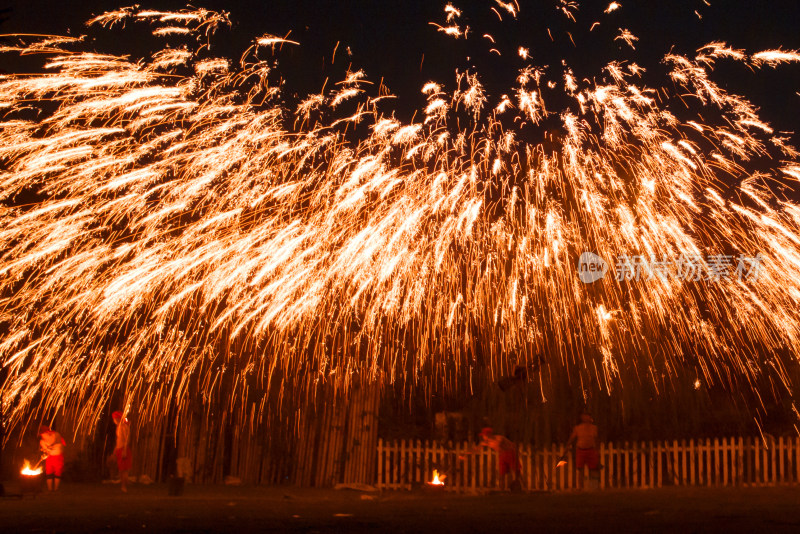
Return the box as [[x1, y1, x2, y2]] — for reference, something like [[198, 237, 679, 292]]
[[0, 0, 800, 436]]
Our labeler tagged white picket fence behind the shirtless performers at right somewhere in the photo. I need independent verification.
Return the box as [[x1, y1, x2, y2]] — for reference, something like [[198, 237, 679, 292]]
[[377, 436, 800, 491]]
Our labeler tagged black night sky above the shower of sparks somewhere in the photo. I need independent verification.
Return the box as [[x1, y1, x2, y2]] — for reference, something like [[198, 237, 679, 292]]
[[0, 0, 800, 130]]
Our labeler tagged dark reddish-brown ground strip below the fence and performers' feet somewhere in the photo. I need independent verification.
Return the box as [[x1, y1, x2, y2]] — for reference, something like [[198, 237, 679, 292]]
[[0, 484, 800, 534]]
